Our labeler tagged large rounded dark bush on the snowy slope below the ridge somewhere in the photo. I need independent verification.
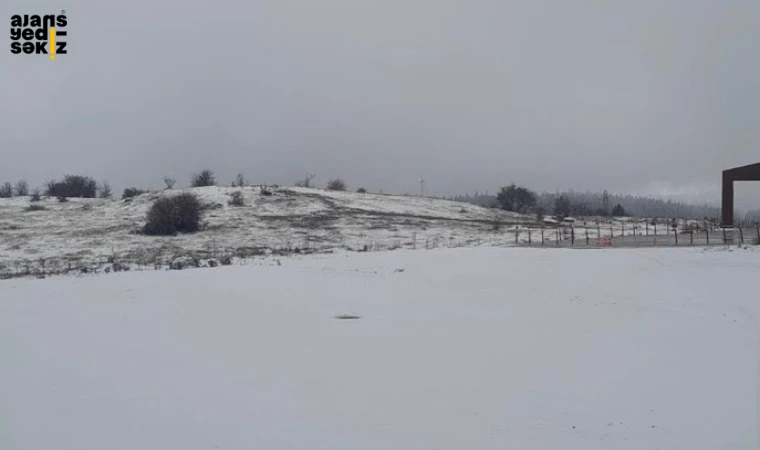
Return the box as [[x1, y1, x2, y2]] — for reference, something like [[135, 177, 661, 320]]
[[143, 194, 202, 236]]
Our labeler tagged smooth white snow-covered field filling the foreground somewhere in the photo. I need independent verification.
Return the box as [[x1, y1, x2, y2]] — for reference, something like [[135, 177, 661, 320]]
[[0, 246, 760, 450]]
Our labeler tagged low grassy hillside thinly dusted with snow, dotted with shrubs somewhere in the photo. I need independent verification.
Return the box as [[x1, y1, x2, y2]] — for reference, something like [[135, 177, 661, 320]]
[[0, 187, 535, 274]]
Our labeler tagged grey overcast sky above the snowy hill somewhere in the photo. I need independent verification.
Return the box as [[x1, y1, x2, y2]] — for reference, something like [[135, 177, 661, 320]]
[[0, 0, 760, 206]]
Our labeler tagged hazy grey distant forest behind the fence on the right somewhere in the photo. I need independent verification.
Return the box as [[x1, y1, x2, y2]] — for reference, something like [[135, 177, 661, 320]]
[[448, 191, 720, 220]]
